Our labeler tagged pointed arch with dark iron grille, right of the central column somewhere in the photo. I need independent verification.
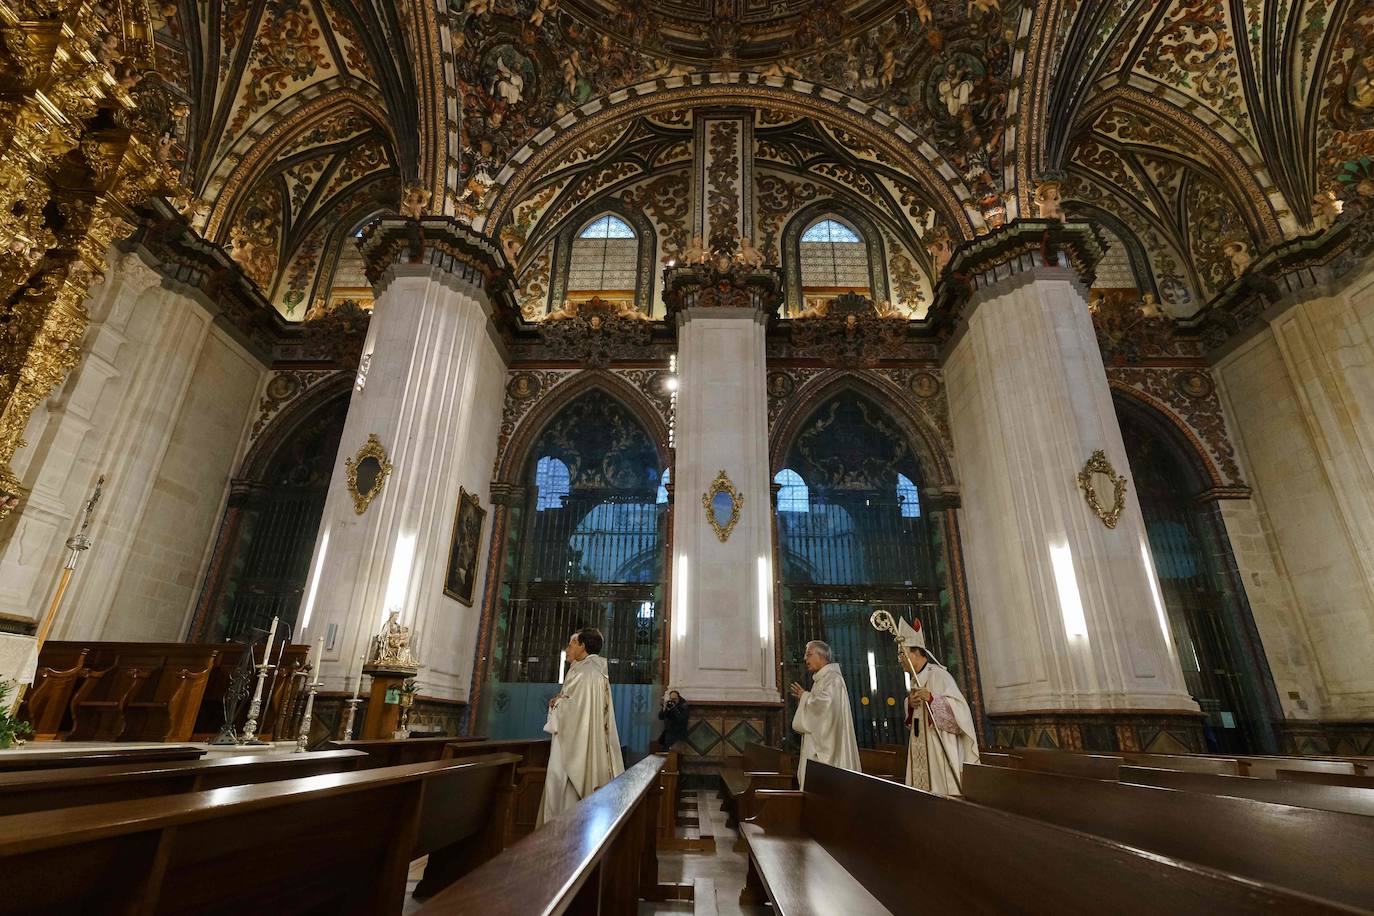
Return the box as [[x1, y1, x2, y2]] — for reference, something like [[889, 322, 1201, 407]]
[[775, 391, 958, 747]]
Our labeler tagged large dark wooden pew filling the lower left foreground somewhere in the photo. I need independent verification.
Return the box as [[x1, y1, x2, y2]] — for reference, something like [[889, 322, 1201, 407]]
[[0, 755, 514, 916]]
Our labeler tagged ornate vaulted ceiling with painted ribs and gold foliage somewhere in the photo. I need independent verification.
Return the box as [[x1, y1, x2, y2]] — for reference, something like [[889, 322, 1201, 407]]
[[154, 0, 1374, 325]]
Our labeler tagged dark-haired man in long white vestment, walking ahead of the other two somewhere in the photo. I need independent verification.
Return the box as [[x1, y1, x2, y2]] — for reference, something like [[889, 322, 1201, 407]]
[[539, 628, 625, 824]]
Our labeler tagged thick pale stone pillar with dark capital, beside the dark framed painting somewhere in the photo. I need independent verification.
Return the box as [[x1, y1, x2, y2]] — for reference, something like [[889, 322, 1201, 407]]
[[294, 218, 514, 702]]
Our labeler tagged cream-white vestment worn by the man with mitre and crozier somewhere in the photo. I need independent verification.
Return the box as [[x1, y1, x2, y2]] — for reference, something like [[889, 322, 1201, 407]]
[[907, 662, 978, 795]]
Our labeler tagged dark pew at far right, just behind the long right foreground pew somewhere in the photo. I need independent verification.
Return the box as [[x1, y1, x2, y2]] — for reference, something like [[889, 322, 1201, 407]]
[[963, 765, 1374, 908]]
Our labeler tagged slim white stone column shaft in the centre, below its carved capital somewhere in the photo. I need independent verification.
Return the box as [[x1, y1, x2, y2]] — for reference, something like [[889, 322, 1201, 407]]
[[671, 308, 779, 703]]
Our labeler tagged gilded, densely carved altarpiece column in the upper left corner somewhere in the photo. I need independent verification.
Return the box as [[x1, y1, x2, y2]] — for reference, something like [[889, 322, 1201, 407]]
[[0, 0, 174, 519]]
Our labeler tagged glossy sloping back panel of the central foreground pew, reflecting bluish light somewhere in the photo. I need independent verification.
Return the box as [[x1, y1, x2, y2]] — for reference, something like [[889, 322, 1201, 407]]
[[419, 755, 664, 916]]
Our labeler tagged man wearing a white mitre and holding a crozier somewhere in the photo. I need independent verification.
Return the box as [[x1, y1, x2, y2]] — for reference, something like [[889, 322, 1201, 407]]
[[897, 619, 978, 795]]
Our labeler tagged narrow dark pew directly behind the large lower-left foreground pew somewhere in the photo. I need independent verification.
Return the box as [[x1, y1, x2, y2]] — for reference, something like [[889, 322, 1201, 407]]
[[0, 751, 367, 816]]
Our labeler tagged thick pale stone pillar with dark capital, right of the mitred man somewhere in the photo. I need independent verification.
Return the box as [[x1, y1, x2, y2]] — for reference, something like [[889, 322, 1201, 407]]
[[937, 221, 1198, 725]]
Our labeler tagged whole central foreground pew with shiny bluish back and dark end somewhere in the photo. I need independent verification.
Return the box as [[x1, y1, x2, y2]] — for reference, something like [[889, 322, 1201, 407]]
[[419, 755, 691, 916]]
